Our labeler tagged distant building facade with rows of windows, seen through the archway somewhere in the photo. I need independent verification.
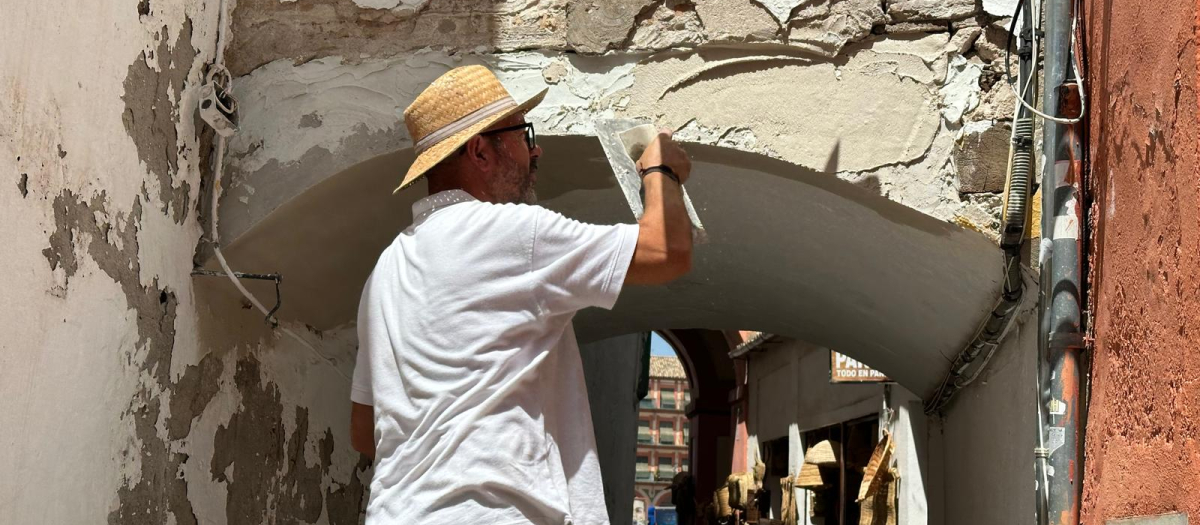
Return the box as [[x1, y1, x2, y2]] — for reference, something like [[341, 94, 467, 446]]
[[634, 356, 691, 520]]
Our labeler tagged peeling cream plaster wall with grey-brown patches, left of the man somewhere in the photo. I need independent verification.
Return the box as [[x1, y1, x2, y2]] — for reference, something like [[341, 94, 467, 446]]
[[0, 0, 366, 524]]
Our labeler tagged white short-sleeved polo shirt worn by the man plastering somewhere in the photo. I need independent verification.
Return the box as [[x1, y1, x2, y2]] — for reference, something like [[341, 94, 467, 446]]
[[350, 191, 638, 525]]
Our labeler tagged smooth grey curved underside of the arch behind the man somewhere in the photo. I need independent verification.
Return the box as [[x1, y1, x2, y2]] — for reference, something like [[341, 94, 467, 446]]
[[223, 137, 1001, 396]]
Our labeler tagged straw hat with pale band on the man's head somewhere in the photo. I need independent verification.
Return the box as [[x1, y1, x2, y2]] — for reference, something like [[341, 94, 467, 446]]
[[392, 66, 547, 193]]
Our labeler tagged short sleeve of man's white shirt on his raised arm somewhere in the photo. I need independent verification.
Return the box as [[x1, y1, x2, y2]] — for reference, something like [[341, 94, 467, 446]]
[[532, 210, 638, 315]]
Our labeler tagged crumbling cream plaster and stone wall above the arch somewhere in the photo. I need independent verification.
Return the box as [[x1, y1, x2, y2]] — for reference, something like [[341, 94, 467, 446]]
[[223, 0, 1014, 244]]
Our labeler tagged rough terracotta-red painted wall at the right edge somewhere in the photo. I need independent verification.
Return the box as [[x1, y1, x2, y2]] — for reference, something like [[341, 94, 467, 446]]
[[1082, 0, 1200, 525]]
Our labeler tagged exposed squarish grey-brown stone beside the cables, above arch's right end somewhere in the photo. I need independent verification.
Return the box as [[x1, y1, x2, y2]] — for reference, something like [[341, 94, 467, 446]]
[[954, 121, 1012, 193]]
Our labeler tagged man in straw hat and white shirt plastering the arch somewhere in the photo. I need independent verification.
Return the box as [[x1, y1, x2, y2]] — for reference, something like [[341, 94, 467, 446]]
[[350, 66, 691, 525]]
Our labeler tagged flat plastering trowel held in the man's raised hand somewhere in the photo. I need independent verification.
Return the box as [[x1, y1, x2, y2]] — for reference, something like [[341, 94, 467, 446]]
[[595, 119, 707, 243]]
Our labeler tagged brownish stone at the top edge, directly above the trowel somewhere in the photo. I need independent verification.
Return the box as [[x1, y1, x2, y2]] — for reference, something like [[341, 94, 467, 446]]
[[566, 0, 653, 54]]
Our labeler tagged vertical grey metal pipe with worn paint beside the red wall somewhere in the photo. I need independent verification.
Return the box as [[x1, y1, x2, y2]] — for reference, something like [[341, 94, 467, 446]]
[[1039, 0, 1084, 525]]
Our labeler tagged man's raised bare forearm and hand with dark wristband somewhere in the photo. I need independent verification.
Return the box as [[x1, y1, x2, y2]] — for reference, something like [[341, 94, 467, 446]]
[[625, 131, 691, 284]]
